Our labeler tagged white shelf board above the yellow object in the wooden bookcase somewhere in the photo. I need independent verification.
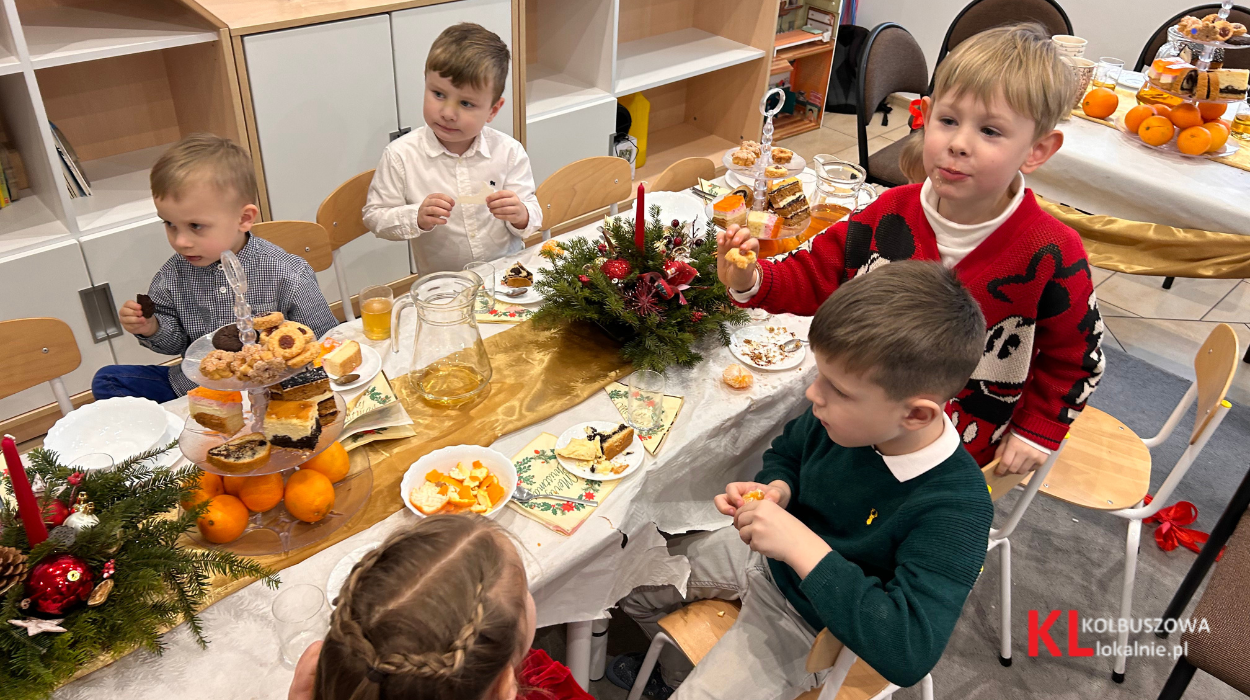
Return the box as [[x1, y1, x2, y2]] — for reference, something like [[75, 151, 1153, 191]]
[[615, 28, 765, 98]]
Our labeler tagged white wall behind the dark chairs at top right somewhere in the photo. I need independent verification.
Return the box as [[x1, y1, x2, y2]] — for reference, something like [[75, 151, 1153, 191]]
[[855, 0, 1190, 74]]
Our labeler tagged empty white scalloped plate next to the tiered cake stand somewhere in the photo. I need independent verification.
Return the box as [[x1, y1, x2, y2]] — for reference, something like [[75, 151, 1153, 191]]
[[44, 396, 169, 464]]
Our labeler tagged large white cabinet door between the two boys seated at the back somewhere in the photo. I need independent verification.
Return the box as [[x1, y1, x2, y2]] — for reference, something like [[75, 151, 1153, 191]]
[[243, 14, 412, 301]]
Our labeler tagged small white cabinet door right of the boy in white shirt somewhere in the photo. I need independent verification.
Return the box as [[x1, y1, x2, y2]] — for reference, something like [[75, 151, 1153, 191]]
[[525, 95, 616, 184]]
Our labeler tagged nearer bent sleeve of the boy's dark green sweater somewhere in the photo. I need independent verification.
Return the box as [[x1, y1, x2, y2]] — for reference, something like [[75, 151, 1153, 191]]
[[800, 495, 994, 688]]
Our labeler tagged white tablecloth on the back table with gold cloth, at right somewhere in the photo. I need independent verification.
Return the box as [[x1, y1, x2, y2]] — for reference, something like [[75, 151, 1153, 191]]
[[1026, 115, 1250, 235]]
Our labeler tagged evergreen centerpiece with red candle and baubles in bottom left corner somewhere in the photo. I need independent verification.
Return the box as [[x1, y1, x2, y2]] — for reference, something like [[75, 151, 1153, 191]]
[[0, 438, 278, 700]]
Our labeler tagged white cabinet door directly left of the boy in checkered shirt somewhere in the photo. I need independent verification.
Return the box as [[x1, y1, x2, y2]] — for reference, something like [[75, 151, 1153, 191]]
[[79, 219, 174, 365]]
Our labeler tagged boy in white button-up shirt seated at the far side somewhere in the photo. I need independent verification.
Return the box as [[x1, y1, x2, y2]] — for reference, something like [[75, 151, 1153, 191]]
[[363, 23, 543, 275]]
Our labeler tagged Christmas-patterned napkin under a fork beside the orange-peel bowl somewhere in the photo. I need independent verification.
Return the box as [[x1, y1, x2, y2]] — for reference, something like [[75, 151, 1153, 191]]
[[508, 433, 620, 535]]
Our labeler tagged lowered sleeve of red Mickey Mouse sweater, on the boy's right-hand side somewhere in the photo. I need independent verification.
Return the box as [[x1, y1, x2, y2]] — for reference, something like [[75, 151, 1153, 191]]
[[1011, 237, 1104, 450]]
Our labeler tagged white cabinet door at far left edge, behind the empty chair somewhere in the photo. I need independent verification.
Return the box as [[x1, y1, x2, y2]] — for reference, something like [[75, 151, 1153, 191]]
[[0, 240, 113, 419]]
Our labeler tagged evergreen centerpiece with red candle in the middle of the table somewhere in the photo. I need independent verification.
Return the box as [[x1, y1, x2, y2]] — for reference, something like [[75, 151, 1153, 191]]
[[534, 185, 748, 371]]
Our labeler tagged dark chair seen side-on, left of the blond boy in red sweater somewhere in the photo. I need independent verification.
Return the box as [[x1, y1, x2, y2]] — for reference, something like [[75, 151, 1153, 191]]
[[855, 23, 929, 188]]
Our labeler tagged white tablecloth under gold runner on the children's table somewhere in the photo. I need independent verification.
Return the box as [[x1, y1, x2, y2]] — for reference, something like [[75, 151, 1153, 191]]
[[56, 188, 815, 700]]
